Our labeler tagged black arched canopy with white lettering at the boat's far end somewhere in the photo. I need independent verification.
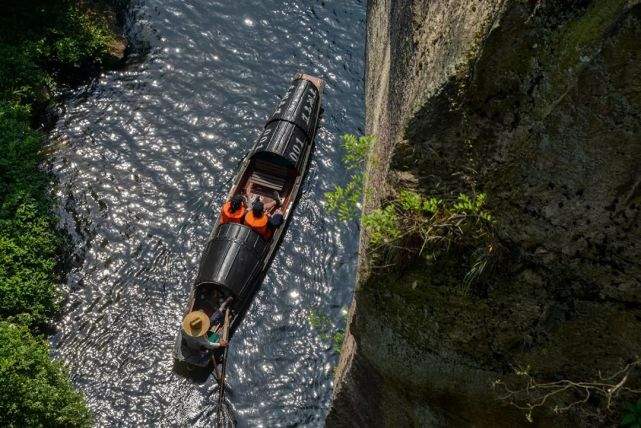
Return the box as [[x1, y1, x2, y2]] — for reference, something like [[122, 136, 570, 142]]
[[251, 75, 322, 174]]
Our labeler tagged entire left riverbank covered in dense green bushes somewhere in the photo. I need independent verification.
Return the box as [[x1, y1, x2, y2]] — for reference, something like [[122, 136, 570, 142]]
[[0, 0, 126, 426]]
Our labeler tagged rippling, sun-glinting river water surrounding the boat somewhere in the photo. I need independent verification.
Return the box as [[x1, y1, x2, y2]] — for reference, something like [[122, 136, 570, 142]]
[[47, 0, 365, 426]]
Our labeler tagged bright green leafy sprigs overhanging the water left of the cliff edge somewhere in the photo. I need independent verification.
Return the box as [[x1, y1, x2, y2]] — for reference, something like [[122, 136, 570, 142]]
[[325, 134, 374, 221]]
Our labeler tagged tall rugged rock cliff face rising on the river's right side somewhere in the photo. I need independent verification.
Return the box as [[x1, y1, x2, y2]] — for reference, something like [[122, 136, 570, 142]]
[[327, 0, 641, 427]]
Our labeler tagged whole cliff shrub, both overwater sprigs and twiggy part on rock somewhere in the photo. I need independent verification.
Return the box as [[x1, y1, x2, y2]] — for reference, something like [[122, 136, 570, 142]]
[[325, 134, 498, 291]]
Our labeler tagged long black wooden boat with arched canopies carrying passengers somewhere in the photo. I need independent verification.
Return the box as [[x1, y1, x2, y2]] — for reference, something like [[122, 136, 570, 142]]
[[174, 74, 324, 380]]
